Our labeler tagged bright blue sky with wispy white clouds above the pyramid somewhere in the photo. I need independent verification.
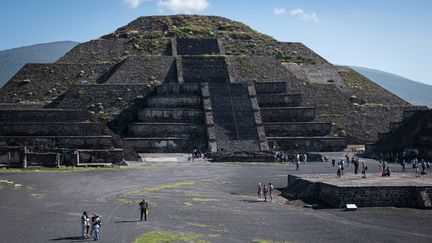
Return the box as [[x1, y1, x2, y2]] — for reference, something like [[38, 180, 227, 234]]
[[0, 0, 432, 84]]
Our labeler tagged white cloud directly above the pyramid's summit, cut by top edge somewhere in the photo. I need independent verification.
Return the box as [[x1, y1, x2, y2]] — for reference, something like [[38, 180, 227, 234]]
[[158, 0, 210, 13]]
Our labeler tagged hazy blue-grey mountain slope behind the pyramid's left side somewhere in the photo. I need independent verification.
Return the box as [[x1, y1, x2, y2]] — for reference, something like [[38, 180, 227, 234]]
[[0, 41, 79, 87]]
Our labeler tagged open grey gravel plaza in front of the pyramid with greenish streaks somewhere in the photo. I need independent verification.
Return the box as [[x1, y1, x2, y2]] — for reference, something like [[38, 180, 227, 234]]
[[0, 154, 432, 242]]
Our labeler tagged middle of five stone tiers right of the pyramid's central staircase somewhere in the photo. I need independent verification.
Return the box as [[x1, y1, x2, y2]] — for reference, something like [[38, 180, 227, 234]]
[[261, 107, 316, 123]]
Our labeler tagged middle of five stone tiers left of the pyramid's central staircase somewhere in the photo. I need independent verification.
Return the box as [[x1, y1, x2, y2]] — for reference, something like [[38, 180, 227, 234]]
[[138, 108, 203, 123]]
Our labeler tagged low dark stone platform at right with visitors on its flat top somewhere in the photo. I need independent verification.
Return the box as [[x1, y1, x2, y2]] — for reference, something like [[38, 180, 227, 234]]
[[282, 173, 432, 209]]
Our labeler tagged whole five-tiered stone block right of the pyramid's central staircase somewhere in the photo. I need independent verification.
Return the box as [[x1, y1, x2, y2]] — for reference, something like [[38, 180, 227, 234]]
[[255, 82, 346, 152]]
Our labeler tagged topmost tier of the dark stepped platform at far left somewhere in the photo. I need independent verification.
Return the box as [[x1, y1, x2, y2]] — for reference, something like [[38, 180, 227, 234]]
[[0, 109, 88, 122]]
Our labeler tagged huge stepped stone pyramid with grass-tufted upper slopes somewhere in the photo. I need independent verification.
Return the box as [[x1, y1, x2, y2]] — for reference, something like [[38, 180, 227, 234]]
[[0, 15, 426, 164]]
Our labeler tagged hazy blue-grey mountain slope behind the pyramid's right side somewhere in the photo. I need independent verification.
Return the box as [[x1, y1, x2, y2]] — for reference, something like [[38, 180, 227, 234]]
[[350, 66, 432, 108]]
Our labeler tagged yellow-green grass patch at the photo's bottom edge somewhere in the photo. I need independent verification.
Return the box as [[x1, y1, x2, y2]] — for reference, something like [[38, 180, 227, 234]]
[[133, 231, 208, 243]]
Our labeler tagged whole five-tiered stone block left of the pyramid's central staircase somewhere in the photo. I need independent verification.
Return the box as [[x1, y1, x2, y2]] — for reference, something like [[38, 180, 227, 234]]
[[123, 83, 207, 153]]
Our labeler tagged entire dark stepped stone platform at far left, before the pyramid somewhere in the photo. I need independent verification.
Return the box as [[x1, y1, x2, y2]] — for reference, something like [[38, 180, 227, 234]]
[[0, 108, 123, 167]]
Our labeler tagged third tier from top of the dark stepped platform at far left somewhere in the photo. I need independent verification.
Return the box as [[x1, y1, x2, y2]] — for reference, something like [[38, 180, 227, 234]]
[[0, 135, 112, 149]]
